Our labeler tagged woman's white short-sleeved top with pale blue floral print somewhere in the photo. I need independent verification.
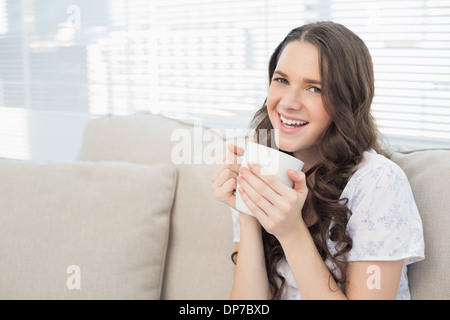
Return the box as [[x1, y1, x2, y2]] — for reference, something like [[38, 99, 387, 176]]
[[342, 151, 424, 264]]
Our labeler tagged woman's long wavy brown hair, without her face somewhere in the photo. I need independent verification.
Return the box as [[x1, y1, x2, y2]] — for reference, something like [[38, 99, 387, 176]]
[[233, 21, 384, 299]]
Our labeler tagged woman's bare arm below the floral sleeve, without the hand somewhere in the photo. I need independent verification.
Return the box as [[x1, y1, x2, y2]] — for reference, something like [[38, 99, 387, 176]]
[[280, 222, 403, 300]]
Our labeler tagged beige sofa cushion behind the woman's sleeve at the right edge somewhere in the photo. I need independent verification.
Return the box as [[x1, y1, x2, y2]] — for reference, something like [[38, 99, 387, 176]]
[[391, 150, 450, 299]]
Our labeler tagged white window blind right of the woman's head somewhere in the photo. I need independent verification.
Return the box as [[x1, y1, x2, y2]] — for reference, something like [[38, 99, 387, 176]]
[[330, 0, 450, 143]]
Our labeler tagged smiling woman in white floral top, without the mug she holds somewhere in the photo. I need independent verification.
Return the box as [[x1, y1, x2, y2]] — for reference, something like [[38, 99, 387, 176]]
[[212, 22, 424, 299]]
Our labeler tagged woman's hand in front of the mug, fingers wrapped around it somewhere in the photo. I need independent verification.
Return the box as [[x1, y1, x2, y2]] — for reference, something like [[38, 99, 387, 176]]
[[238, 163, 308, 240]]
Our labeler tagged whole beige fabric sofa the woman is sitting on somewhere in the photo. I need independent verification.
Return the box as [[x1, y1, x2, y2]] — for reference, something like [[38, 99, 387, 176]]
[[0, 114, 450, 299]]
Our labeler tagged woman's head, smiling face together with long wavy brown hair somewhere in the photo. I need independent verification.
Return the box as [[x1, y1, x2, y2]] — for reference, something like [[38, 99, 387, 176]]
[[246, 23, 381, 300]]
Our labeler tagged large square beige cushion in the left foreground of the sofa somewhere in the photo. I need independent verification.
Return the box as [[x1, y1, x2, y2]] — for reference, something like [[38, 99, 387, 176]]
[[0, 161, 177, 299]]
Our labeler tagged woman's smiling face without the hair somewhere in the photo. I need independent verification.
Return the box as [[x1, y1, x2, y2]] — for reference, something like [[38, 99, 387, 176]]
[[267, 41, 331, 160]]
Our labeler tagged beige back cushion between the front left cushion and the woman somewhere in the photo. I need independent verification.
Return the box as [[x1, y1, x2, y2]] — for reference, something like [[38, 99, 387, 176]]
[[77, 113, 234, 299]]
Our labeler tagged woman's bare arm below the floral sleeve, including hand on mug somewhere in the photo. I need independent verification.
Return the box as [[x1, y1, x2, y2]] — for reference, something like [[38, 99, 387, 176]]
[[240, 165, 403, 299]]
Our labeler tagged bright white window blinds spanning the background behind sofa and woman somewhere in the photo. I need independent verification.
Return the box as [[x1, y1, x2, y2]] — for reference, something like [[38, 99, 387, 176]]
[[0, 0, 450, 160]]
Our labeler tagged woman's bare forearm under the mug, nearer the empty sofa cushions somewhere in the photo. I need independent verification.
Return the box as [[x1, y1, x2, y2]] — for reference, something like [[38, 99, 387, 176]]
[[230, 213, 271, 299]]
